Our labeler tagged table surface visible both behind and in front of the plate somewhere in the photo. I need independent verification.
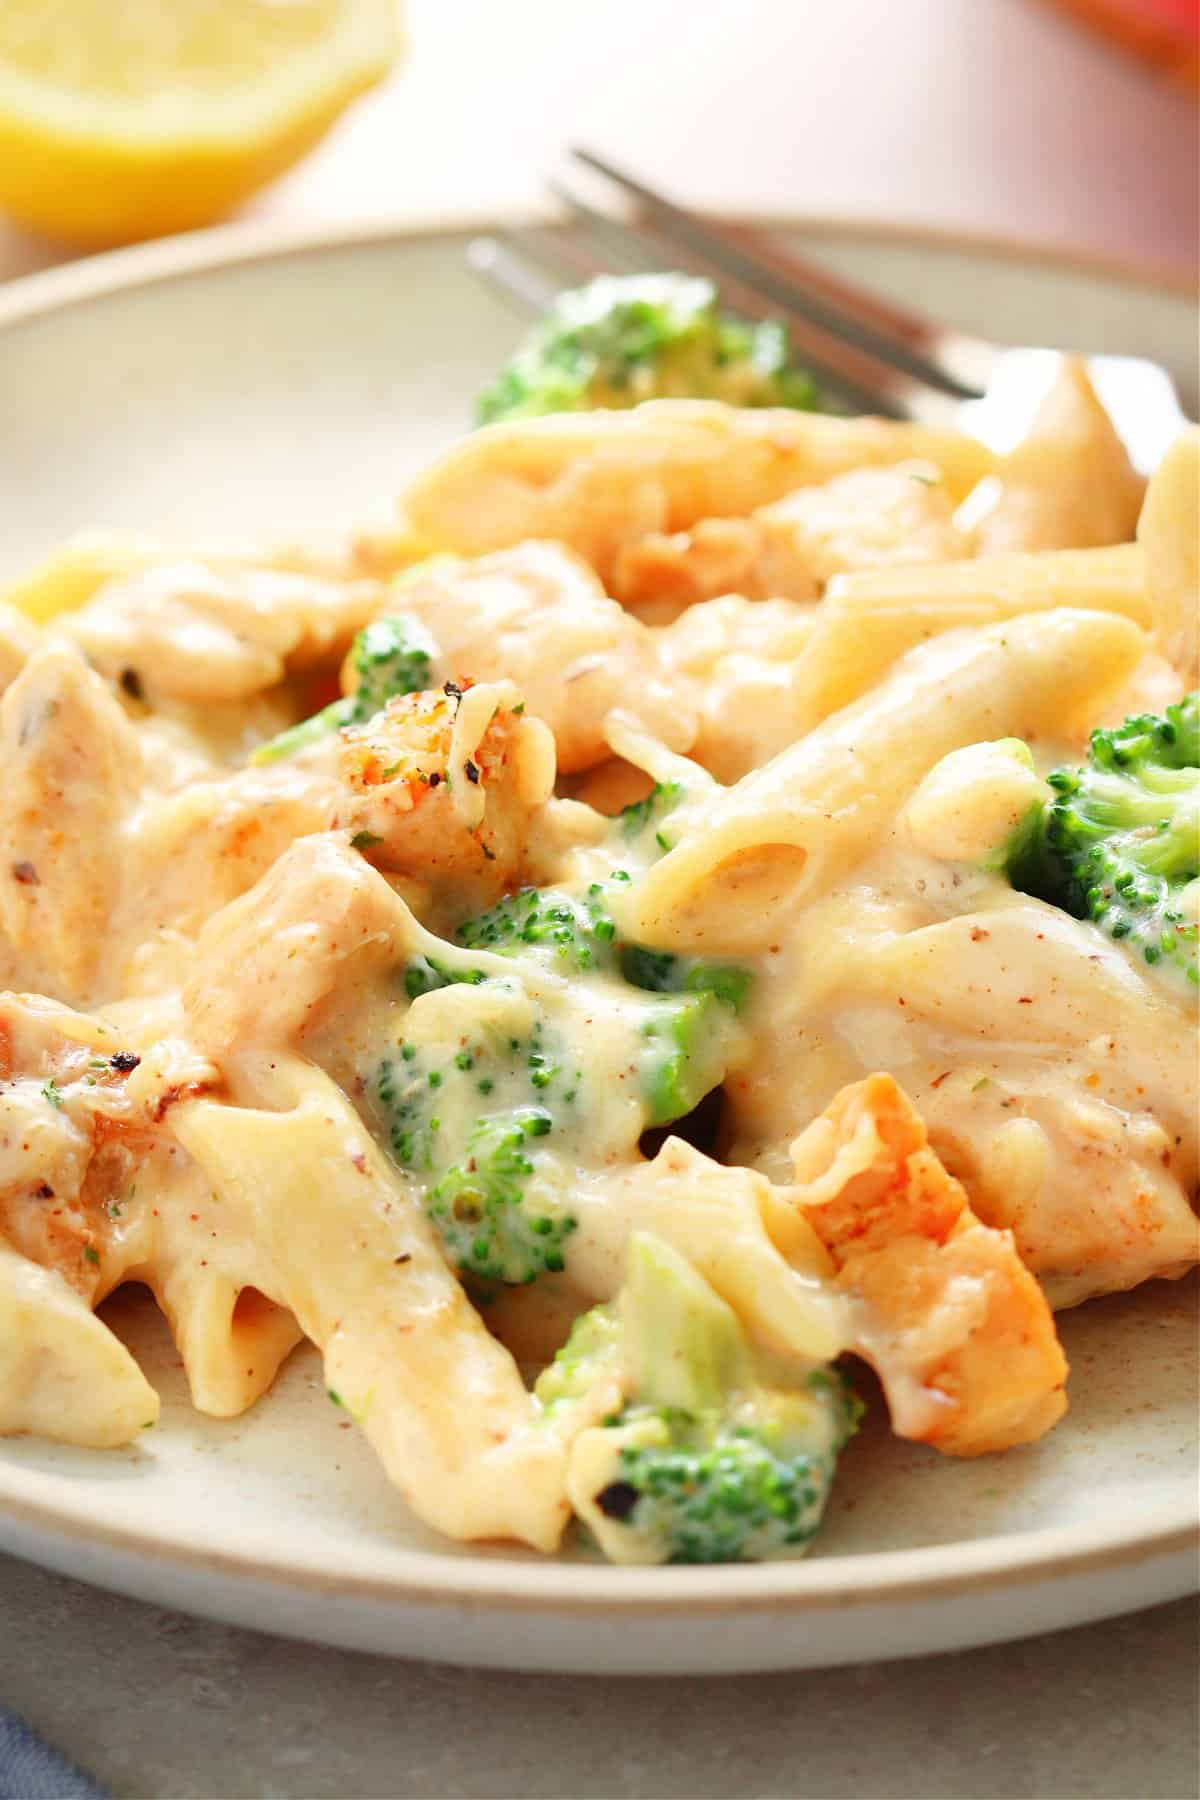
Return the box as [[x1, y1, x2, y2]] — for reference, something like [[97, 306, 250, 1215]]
[[0, 0, 1200, 1800]]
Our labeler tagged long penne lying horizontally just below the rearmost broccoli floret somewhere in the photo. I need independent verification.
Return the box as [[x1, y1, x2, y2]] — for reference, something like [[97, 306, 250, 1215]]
[[403, 400, 995, 583]]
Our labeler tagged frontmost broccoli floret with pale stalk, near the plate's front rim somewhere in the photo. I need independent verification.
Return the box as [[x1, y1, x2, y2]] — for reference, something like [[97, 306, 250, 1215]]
[[534, 1233, 862, 1562]]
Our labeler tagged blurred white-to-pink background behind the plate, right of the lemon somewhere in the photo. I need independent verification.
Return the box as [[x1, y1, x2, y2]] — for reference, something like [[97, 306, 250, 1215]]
[[0, 0, 1200, 279]]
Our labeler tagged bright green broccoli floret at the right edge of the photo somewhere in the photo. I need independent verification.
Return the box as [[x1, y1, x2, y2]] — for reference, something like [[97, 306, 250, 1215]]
[[1009, 693, 1200, 985]]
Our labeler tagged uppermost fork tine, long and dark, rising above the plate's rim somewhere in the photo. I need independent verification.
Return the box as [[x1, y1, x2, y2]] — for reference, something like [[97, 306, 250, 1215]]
[[570, 148, 981, 400]]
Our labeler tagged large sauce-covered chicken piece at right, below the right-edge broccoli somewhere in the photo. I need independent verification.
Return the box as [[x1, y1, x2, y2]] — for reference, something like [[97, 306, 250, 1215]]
[[729, 900, 1200, 1307]]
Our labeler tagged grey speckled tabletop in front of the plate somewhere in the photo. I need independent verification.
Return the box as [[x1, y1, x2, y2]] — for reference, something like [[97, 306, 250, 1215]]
[[0, 1557, 1200, 1800]]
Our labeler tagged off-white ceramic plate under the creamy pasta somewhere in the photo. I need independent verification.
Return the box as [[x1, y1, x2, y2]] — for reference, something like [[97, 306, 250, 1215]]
[[0, 227, 1200, 1672]]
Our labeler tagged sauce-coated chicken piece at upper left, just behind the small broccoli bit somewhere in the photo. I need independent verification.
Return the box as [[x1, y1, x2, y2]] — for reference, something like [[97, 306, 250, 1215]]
[[58, 562, 380, 702]]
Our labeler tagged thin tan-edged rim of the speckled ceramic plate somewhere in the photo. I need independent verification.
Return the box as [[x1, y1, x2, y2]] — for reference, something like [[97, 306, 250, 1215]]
[[0, 214, 1200, 1618]]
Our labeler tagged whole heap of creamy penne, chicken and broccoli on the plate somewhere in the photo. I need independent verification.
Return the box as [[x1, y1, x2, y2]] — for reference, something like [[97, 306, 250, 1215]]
[[0, 390, 1200, 1562]]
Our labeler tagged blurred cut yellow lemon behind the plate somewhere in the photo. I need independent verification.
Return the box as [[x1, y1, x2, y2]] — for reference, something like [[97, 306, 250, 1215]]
[[0, 0, 399, 248]]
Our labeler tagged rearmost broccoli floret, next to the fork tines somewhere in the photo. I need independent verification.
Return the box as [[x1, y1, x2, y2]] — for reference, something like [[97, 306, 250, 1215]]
[[479, 274, 820, 425]]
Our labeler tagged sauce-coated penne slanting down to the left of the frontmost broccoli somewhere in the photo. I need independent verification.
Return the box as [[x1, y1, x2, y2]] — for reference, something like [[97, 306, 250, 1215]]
[[173, 1060, 569, 1550]]
